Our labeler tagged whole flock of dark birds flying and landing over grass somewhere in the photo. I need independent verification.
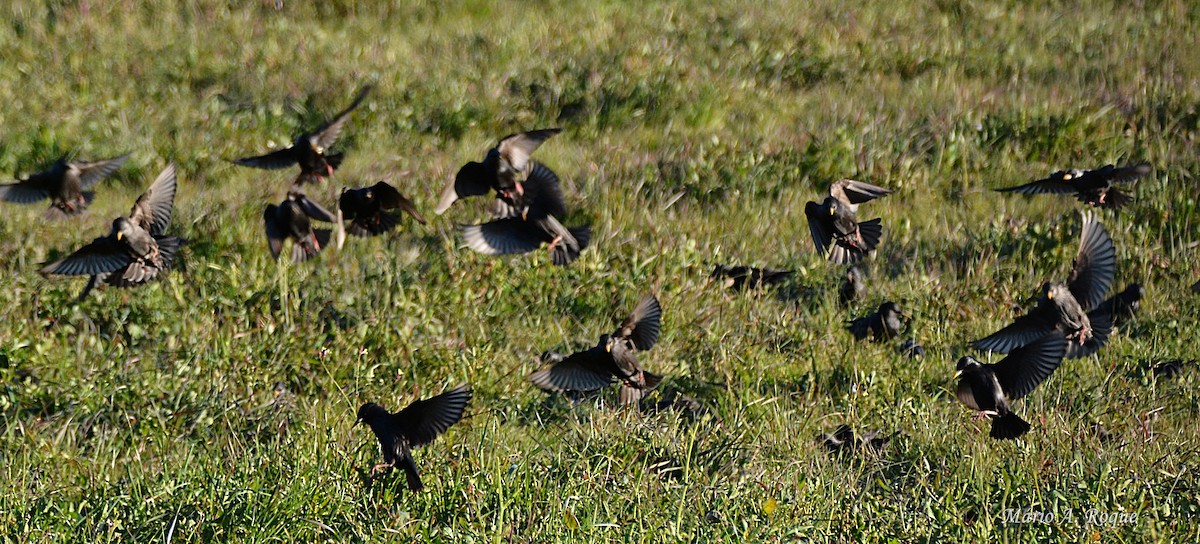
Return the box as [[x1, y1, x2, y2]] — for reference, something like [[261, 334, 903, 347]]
[[0, 86, 1180, 490]]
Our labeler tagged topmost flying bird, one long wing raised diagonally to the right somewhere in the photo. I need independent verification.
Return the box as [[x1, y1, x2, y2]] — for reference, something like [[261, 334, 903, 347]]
[[233, 85, 371, 185]]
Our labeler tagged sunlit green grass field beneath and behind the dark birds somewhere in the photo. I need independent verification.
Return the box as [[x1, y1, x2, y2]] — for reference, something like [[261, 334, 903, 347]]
[[0, 0, 1200, 543]]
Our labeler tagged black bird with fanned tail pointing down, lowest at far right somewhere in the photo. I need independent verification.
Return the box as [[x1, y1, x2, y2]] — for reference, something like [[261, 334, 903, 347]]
[[954, 334, 1067, 440]]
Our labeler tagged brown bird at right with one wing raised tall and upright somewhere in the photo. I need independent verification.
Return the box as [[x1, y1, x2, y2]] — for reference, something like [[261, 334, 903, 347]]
[[974, 213, 1117, 359]]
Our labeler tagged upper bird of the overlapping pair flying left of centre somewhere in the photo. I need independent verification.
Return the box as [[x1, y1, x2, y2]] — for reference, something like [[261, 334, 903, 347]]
[[434, 128, 563, 215]]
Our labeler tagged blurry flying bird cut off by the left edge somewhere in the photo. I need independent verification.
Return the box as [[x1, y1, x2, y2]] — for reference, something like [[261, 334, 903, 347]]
[[0, 154, 130, 216]]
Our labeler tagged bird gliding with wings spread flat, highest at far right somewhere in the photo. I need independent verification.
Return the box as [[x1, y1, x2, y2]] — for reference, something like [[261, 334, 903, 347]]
[[996, 165, 1151, 208]]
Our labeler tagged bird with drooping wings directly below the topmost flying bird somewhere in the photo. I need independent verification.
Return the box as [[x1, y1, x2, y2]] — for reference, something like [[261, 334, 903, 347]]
[[263, 192, 337, 263]]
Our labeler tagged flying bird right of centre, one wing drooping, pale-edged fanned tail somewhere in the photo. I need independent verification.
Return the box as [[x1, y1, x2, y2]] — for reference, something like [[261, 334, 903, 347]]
[[804, 179, 892, 264]]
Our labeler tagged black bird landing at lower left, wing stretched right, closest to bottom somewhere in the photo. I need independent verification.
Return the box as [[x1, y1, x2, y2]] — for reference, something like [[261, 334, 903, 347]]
[[355, 385, 472, 491]]
